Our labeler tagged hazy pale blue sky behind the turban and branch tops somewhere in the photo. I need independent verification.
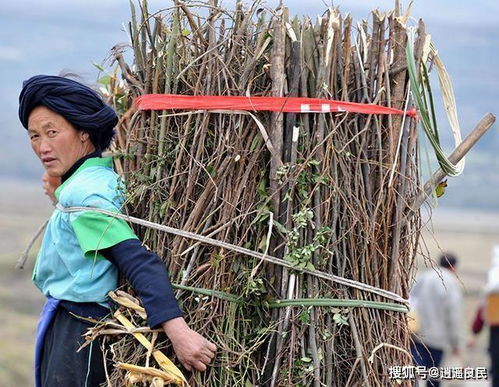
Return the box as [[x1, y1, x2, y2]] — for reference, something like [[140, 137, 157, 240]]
[[0, 0, 499, 183]]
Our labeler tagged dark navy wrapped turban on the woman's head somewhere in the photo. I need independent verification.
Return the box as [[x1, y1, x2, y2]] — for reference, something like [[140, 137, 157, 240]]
[[19, 75, 118, 150]]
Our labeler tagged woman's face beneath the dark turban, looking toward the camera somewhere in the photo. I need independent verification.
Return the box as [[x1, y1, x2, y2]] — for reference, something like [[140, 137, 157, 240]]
[[28, 106, 95, 177]]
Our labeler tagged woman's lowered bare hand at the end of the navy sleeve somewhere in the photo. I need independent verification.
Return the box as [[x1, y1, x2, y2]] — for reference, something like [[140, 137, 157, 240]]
[[162, 317, 217, 371]]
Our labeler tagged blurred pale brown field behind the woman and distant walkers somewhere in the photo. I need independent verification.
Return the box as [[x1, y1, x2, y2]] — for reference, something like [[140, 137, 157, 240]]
[[0, 180, 499, 387]]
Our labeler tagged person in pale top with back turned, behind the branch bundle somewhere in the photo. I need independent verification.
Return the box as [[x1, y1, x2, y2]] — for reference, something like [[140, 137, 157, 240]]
[[410, 253, 462, 386]]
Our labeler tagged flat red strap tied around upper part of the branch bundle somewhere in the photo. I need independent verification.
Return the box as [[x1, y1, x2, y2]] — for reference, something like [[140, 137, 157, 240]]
[[135, 94, 416, 117]]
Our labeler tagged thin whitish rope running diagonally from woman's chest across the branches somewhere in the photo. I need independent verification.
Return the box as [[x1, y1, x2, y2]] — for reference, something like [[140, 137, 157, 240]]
[[56, 203, 409, 305]]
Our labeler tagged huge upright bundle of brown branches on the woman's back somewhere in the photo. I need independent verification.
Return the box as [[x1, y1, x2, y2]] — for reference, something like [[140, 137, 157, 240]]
[[99, 0, 432, 386]]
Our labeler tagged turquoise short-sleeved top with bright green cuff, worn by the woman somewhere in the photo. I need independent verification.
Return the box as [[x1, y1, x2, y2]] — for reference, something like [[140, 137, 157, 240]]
[[33, 157, 137, 304]]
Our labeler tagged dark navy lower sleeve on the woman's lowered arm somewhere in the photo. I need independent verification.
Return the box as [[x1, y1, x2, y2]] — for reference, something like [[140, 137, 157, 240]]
[[101, 239, 182, 328]]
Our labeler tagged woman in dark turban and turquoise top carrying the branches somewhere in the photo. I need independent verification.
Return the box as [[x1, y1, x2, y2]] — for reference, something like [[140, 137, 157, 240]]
[[19, 75, 216, 387]]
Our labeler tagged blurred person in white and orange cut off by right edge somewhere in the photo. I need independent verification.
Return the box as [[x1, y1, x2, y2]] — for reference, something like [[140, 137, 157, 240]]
[[468, 245, 499, 387]]
